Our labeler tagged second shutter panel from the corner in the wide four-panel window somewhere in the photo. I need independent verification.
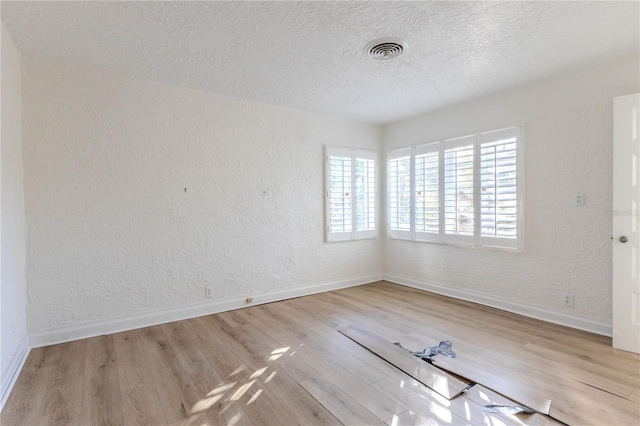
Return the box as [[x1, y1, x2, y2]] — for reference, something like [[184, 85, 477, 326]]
[[414, 142, 442, 242]]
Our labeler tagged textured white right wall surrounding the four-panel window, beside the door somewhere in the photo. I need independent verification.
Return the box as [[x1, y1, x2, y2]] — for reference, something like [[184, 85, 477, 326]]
[[383, 57, 639, 321]]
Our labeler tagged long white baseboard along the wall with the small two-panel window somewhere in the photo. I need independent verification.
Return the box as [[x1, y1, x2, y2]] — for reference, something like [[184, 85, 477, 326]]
[[29, 274, 382, 348]]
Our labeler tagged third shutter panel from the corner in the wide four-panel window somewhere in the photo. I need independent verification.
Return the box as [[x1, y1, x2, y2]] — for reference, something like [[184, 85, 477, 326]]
[[444, 136, 476, 244]]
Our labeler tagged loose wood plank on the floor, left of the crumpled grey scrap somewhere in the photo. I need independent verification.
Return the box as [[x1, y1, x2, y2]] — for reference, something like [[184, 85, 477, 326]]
[[339, 327, 467, 400]]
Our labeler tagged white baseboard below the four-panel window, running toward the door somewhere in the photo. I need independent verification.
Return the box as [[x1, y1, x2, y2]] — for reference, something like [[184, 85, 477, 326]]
[[383, 274, 613, 337]]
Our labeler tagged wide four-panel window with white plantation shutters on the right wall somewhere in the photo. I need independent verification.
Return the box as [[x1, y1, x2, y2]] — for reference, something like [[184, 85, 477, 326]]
[[387, 127, 523, 248]]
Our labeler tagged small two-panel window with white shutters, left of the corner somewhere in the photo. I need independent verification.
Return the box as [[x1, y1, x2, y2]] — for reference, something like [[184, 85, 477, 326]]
[[325, 146, 376, 241]]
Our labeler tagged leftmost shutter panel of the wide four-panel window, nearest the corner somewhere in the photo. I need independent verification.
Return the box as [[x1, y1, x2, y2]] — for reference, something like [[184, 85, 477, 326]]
[[387, 148, 413, 239]]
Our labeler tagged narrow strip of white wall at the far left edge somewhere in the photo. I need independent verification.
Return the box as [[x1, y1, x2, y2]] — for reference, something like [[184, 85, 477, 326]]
[[0, 23, 29, 408]]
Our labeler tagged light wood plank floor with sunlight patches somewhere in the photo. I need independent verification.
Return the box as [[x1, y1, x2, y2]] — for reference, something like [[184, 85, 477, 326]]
[[1, 282, 640, 426]]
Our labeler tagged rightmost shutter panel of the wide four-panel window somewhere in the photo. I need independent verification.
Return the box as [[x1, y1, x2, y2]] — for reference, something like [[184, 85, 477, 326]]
[[479, 127, 521, 248]]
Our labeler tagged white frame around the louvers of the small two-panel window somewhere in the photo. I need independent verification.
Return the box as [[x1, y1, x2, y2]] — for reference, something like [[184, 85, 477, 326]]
[[324, 145, 379, 243]]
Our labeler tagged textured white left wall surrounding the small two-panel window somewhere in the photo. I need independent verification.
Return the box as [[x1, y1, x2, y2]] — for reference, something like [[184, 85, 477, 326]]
[[22, 57, 382, 333]]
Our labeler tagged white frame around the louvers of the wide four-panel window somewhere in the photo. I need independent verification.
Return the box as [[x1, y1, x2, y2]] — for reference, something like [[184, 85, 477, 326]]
[[386, 125, 525, 250]]
